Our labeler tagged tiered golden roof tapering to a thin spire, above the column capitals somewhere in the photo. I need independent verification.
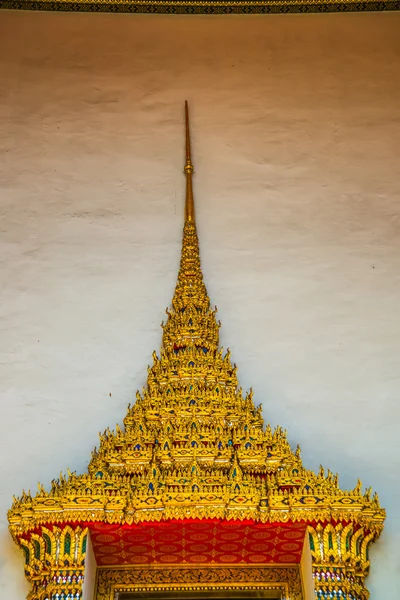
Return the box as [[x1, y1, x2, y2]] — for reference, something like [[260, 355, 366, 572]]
[[8, 105, 385, 597]]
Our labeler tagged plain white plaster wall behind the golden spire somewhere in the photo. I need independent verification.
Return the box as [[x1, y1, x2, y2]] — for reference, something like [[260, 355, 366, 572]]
[[0, 12, 400, 600]]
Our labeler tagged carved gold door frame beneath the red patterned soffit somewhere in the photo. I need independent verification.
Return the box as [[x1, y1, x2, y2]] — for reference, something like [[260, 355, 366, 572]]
[[96, 565, 303, 600]]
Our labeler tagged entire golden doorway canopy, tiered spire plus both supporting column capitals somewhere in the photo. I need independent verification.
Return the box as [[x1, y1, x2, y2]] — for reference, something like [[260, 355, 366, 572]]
[[8, 103, 385, 600]]
